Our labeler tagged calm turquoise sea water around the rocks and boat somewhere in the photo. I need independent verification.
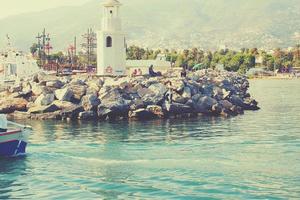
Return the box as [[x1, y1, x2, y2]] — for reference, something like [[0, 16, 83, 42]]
[[0, 80, 300, 199]]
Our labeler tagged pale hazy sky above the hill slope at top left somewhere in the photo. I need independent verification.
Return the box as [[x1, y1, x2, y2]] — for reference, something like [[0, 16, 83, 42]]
[[0, 0, 90, 18]]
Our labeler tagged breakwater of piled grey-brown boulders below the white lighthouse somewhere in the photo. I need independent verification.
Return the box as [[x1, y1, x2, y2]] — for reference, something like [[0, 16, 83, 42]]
[[0, 70, 259, 120]]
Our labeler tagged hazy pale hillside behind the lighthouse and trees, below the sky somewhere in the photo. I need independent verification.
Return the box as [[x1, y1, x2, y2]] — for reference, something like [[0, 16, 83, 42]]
[[0, 0, 300, 49]]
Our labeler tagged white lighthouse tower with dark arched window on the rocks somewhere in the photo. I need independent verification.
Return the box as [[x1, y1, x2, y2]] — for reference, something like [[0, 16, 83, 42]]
[[97, 0, 126, 76]]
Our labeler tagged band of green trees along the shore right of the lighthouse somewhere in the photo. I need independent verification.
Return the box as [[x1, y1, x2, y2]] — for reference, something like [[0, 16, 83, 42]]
[[127, 45, 300, 73]]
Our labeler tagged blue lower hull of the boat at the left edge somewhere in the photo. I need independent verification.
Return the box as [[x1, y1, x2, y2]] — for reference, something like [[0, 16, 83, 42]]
[[0, 140, 27, 157]]
